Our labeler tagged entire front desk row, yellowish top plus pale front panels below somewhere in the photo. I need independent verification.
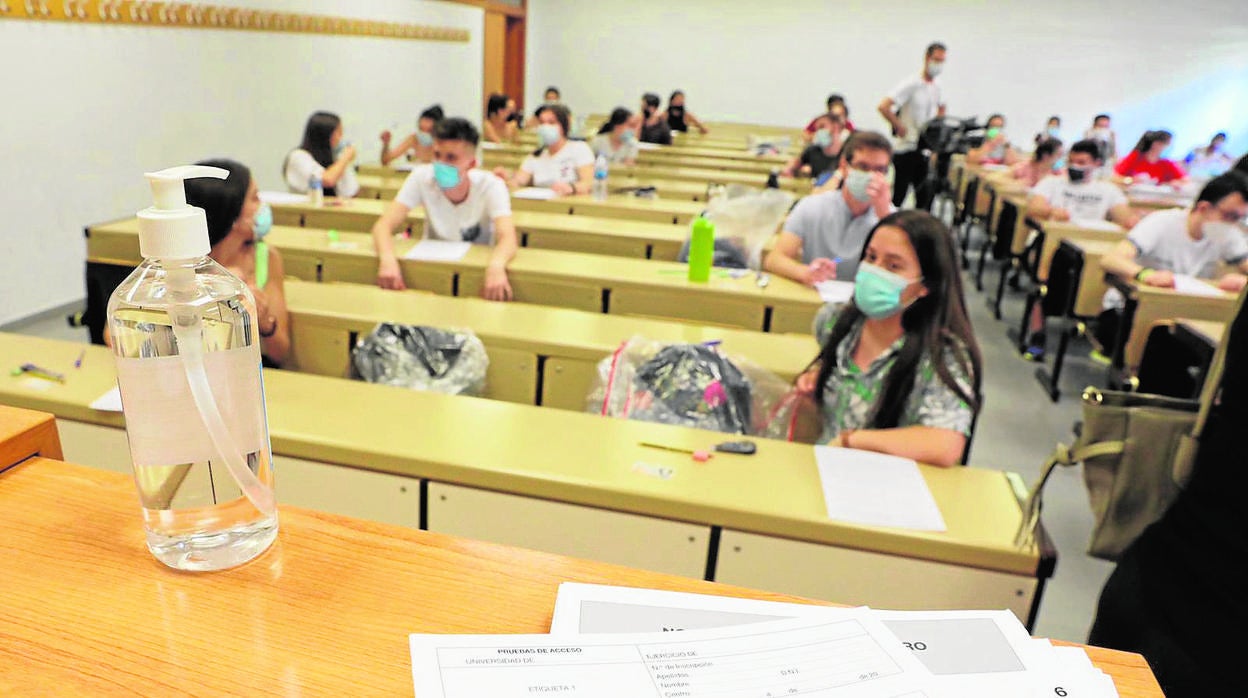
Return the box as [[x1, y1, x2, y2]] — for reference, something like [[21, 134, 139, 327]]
[[0, 335, 1053, 629]]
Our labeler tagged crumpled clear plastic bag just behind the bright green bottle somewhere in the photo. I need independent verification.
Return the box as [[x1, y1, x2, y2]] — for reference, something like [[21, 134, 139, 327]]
[[678, 185, 794, 271]]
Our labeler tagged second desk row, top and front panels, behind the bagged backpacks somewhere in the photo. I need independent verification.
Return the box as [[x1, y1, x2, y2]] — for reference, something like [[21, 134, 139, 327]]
[[286, 281, 819, 411]]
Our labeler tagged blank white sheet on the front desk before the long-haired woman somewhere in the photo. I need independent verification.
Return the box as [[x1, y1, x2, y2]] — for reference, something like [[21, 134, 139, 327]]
[[815, 446, 946, 531]]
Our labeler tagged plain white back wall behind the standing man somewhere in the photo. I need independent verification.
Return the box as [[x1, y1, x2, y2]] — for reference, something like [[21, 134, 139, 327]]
[[527, 0, 1248, 157]]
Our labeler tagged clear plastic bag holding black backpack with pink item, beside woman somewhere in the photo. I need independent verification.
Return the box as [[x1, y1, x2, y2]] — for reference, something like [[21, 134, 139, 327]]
[[587, 337, 817, 438]]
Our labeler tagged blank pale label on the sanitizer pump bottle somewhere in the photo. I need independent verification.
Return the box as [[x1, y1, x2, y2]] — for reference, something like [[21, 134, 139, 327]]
[[117, 346, 267, 467]]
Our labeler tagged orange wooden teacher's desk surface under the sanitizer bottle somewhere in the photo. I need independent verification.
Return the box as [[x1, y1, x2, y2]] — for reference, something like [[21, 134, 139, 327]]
[[0, 458, 1161, 698]]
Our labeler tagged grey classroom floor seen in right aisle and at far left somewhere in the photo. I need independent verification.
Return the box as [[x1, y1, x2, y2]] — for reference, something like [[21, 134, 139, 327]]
[[5, 245, 1112, 642]]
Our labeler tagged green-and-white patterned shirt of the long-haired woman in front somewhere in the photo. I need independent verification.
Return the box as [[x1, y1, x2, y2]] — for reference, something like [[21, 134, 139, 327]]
[[820, 308, 975, 442]]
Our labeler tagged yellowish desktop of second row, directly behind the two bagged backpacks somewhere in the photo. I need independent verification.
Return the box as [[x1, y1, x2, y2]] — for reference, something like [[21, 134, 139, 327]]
[[286, 281, 819, 380]]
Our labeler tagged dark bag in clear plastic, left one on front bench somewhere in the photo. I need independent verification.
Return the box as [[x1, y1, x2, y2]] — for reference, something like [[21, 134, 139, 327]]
[[351, 322, 489, 396]]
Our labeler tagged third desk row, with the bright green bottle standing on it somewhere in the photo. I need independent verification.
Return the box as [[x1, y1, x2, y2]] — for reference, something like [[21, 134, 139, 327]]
[[87, 219, 821, 333]]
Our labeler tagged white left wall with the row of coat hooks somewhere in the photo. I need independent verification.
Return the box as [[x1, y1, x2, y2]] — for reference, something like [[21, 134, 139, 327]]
[[0, 0, 484, 323]]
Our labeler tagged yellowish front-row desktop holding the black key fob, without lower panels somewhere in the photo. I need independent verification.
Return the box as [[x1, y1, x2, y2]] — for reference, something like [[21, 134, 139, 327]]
[[0, 333, 1041, 578]]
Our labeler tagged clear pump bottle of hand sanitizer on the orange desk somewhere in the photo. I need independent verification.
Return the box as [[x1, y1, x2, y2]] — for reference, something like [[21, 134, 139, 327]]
[[107, 166, 277, 571]]
